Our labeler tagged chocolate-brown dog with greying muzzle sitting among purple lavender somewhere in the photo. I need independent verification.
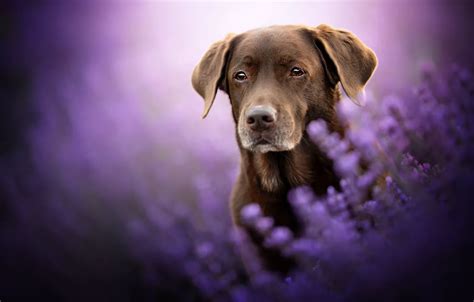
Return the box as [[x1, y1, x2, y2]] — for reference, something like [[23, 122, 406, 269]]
[[192, 25, 377, 272]]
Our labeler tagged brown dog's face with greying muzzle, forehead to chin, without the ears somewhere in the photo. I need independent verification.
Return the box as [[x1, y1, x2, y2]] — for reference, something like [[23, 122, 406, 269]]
[[226, 27, 329, 152]]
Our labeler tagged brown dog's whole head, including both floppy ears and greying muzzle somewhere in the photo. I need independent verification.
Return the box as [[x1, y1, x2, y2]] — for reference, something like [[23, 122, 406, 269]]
[[192, 25, 377, 153]]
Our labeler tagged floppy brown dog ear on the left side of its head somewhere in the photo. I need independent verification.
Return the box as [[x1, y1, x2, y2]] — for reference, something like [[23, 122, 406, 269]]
[[192, 34, 235, 118]]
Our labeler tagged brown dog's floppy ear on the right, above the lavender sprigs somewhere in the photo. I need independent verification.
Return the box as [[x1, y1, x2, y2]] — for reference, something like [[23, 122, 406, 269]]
[[311, 24, 377, 105]]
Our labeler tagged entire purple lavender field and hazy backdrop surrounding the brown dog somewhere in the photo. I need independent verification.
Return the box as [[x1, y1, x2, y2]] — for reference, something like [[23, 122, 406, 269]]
[[0, 1, 474, 301]]
